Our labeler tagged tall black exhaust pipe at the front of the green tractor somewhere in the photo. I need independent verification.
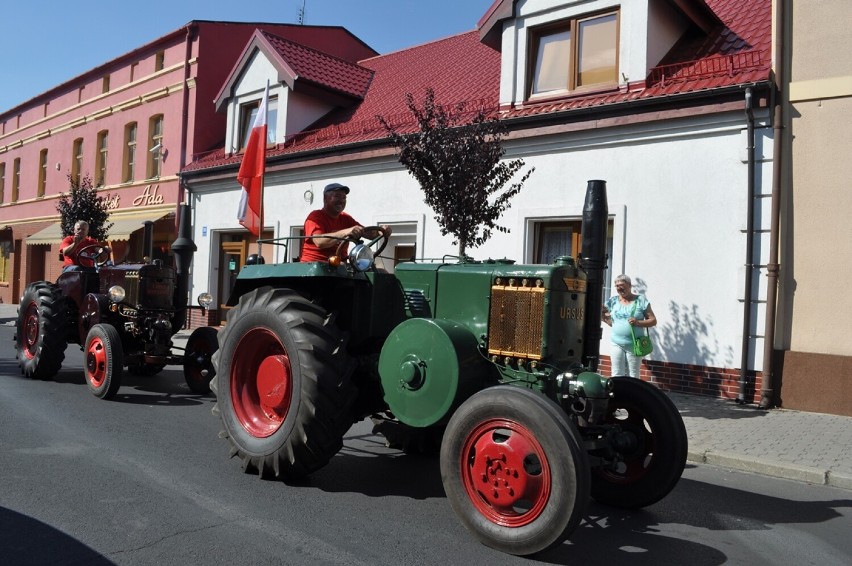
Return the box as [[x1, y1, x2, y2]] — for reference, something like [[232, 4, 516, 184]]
[[580, 180, 609, 371]]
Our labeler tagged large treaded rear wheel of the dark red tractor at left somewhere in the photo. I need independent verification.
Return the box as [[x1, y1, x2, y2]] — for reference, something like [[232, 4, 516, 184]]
[[15, 281, 68, 379]]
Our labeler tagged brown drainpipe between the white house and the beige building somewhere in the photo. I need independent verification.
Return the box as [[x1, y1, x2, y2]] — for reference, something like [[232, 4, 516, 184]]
[[758, 0, 787, 409]]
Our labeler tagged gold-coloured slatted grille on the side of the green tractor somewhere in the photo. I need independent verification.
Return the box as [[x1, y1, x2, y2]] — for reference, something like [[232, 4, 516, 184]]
[[488, 279, 544, 360]]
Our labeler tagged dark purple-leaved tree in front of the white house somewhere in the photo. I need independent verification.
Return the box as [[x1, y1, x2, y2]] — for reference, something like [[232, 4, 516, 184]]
[[378, 88, 535, 258]]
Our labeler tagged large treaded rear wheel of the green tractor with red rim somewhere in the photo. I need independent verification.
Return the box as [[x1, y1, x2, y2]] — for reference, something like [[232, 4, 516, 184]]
[[211, 287, 357, 479]]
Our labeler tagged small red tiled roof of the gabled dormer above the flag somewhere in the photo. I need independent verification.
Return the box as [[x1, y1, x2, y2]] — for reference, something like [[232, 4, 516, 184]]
[[261, 32, 373, 98]]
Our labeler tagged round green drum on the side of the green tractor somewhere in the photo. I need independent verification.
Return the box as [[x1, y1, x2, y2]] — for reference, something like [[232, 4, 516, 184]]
[[379, 318, 488, 427]]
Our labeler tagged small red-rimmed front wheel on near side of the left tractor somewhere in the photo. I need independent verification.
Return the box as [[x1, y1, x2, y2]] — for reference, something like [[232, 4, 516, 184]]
[[83, 324, 124, 400]]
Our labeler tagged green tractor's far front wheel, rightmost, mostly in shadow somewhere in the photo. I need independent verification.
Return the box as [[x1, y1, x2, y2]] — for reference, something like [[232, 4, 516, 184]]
[[592, 377, 689, 509]]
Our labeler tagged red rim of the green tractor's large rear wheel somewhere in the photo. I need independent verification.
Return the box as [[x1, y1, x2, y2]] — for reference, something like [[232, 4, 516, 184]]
[[230, 328, 293, 438]]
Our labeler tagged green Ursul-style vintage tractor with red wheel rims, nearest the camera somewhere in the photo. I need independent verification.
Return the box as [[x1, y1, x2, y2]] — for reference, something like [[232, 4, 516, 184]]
[[211, 181, 687, 555]]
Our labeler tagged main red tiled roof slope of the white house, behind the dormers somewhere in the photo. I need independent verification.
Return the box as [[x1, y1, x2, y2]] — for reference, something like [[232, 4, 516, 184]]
[[185, 0, 772, 171]]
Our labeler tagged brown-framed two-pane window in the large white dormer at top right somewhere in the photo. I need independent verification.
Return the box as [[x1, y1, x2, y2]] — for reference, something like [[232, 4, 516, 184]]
[[529, 11, 618, 98]]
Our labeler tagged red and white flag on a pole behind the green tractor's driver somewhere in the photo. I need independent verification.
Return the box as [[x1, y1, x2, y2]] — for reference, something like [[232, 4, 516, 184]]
[[237, 82, 269, 238]]
